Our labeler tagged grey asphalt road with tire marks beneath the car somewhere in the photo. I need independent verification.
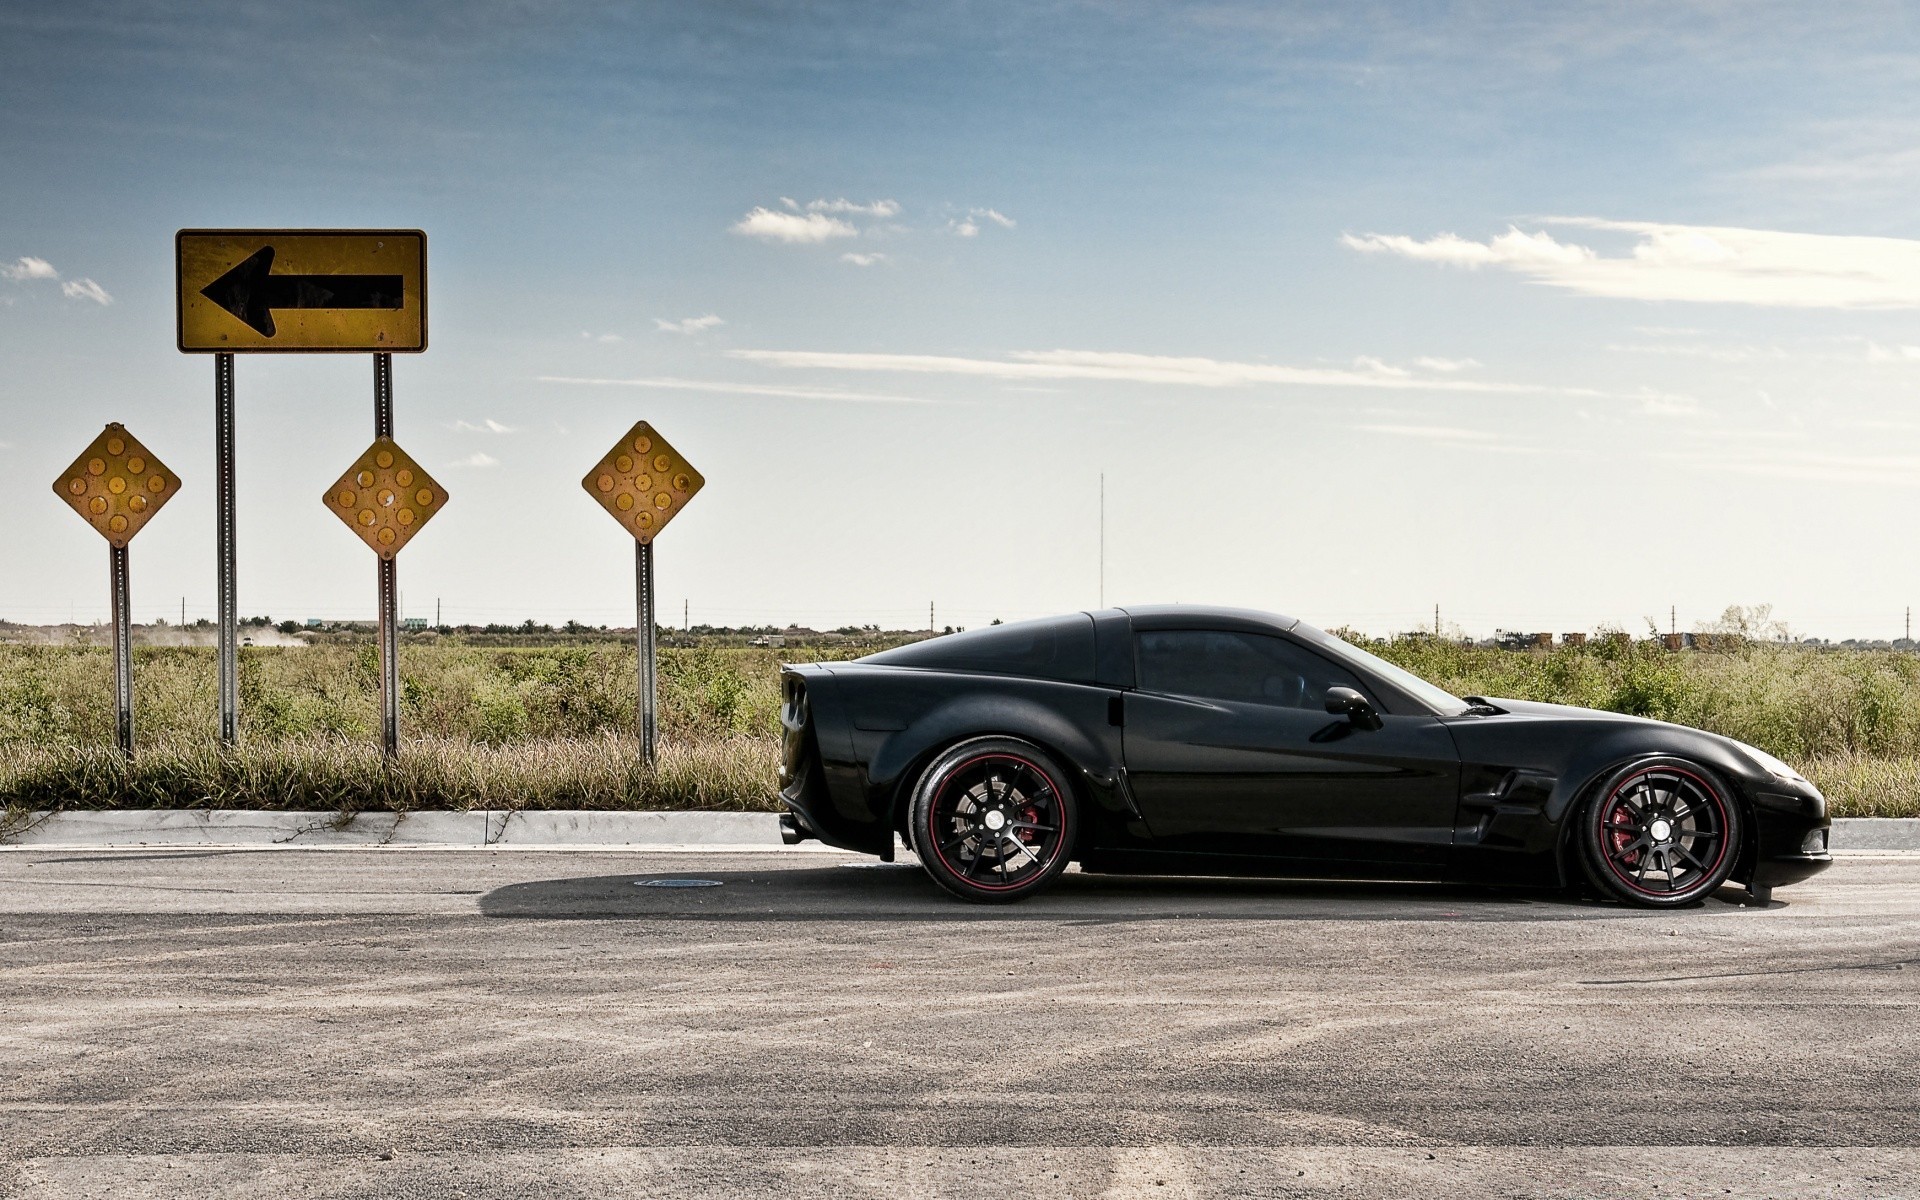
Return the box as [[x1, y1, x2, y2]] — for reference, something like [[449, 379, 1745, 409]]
[[0, 851, 1920, 1200]]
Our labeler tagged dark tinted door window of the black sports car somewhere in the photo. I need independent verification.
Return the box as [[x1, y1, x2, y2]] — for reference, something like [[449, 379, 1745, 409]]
[[1135, 630, 1367, 712]]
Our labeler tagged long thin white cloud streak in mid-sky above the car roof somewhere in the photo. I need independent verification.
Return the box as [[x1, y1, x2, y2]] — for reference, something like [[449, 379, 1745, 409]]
[[728, 349, 1603, 396]]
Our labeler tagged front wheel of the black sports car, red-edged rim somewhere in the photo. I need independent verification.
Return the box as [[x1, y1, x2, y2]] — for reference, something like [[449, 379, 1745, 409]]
[[1576, 758, 1741, 908]]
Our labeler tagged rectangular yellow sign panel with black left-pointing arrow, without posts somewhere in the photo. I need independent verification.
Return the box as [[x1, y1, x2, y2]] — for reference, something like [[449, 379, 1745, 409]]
[[173, 228, 426, 353]]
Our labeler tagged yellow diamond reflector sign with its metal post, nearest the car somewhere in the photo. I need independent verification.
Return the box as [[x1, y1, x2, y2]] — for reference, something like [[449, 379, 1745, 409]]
[[580, 420, 707, 764]]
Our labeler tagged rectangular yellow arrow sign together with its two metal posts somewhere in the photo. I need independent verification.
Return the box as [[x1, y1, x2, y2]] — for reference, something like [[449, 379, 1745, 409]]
[[173, 228, 426, 749]]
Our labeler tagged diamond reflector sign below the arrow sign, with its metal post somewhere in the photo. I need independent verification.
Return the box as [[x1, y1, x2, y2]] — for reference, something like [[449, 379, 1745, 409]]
[[323, 424, 447, 758]]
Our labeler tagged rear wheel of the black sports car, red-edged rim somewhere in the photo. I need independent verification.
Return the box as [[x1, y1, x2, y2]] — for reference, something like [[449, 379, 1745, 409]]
[[908, 737, 1077, 904]]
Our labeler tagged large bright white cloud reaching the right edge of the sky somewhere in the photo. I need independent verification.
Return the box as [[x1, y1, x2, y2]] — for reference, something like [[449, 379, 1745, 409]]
[[1340, 217, 1920, 309]]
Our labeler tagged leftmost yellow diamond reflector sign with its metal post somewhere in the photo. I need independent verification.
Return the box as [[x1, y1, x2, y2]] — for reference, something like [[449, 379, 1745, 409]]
[[54, 422, 180, 755]]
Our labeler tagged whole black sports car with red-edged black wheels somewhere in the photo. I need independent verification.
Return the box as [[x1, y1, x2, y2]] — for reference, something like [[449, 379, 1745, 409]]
[[780, 607, 1832, 908]]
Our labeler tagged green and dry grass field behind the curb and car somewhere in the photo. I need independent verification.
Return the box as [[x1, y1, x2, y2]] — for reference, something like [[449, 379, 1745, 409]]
[[0, 637, 1920, 816]]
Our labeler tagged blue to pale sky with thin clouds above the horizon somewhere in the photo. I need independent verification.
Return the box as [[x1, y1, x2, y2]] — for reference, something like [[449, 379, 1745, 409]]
[[0, 0, 1920, 637]]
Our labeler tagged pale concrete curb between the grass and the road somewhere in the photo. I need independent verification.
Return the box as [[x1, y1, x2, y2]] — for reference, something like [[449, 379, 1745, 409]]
[[0, 808, 1920, 851]]
